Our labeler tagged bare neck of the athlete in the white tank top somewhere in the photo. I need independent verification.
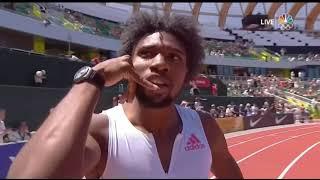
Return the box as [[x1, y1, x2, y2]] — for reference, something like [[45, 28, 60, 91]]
[[122, 98, 182, 135]]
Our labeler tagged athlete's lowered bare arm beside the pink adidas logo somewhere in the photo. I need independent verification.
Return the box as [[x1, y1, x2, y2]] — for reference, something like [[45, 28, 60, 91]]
[[198, 111, 243, 179]]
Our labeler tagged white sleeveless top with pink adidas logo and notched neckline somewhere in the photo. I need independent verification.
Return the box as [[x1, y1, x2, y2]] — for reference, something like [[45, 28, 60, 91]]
[[101, 105, 212, 179]]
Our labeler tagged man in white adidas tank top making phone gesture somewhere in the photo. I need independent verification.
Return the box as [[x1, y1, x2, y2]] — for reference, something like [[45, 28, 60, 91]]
[[8, 13, 242, 178]]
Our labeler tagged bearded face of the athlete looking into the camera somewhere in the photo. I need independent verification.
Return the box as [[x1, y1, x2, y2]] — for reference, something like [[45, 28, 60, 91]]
[[132, 32, 188, 108]]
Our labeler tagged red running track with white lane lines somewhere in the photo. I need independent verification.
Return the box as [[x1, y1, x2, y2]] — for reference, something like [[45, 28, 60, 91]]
[[210, 123, 320, 179]]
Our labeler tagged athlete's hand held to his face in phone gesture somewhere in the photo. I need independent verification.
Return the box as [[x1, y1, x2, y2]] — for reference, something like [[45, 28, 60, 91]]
[[93, 55, 159, 102]]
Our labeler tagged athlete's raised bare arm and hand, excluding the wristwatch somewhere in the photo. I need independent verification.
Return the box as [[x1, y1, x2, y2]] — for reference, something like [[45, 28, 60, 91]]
[[7, 56, 157, 178]]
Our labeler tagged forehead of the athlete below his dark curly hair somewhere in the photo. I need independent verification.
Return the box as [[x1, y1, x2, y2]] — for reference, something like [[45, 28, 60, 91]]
[[136, 32, 186, 54]]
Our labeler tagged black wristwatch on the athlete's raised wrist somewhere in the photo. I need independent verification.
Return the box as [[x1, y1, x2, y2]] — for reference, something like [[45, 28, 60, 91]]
[[73, 66, 105, 89]]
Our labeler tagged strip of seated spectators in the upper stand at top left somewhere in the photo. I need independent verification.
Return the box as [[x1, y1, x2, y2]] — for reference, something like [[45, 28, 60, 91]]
[[0, 3, 122, 39]]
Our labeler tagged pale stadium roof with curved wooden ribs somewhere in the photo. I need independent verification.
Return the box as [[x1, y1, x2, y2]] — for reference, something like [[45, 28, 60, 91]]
[[105, 2, 320, 31]]
